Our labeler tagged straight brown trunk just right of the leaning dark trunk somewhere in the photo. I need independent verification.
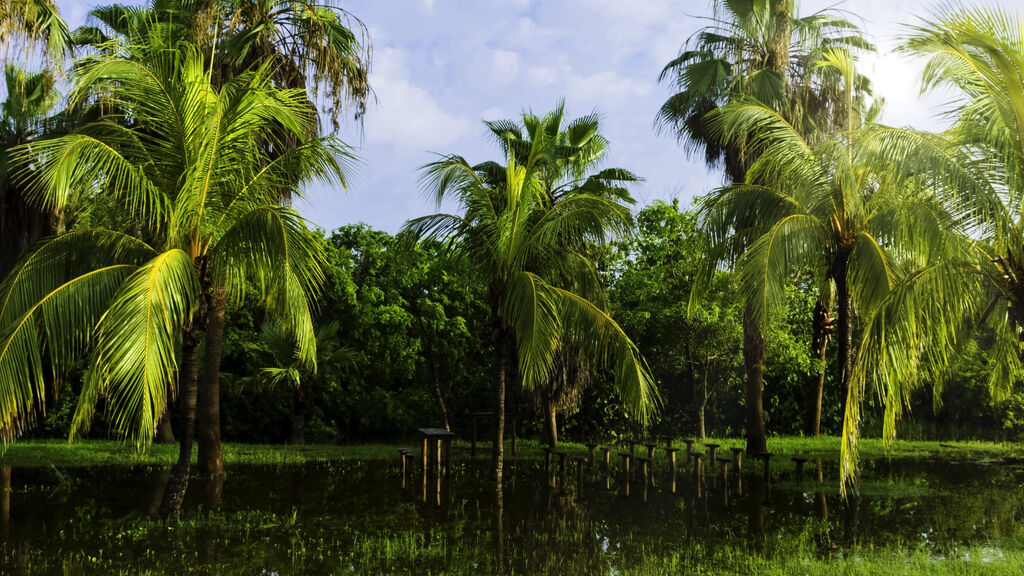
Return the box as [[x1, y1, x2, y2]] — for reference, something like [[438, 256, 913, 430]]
[[199, 289, 227, 476]]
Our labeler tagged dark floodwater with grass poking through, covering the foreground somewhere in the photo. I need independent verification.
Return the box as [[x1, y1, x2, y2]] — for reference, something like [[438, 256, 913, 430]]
[[0, 450, 1024, 575]]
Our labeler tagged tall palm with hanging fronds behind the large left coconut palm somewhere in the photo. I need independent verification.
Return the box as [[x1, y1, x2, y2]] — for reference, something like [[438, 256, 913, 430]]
[[76, 0, 370, 472]]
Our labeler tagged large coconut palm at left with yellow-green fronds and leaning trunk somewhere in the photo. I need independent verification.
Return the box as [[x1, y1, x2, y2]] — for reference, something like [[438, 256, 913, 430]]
[[0, 41, 348, 513]]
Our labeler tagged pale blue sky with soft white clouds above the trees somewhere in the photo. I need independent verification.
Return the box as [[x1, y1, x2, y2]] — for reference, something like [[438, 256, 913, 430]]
[[51, 0, 1013, 232]]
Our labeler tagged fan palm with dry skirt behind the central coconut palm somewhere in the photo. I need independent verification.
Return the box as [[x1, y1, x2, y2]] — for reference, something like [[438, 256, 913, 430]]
[[481, 99, 640, 448]]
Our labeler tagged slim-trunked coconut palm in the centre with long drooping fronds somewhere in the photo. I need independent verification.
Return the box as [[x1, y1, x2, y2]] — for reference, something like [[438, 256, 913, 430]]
[[407, 109, 656, 494]]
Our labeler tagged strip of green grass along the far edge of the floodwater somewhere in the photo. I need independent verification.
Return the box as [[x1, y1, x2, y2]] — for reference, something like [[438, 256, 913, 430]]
[[0, 437, 1024, 470]]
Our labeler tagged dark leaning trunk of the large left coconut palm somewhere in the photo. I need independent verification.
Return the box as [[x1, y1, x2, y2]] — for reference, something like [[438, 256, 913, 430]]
[[160, 327, 199, 518]]
